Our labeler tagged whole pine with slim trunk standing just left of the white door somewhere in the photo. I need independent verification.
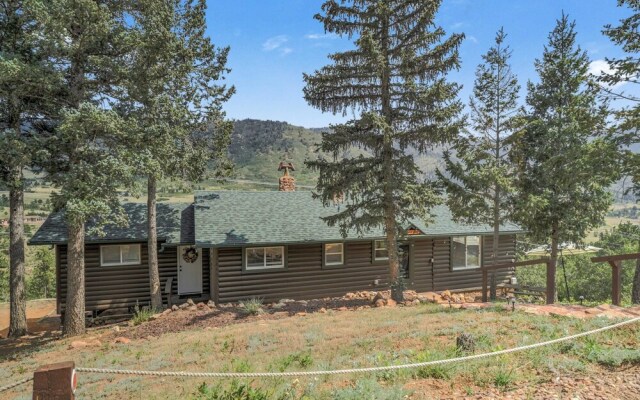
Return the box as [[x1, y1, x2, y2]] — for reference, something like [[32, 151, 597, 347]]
[[118, 0, 234, 310]]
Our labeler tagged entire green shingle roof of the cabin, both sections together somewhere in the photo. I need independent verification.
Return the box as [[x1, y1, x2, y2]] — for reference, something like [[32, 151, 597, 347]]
[[29, 191, 521, 247]]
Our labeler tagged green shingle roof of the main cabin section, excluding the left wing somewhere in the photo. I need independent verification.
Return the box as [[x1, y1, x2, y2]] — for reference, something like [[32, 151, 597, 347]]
[[195, 191, 521, 247]]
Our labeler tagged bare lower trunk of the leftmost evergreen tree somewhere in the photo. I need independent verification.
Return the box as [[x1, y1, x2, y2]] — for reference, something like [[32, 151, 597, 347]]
[[9, 184, 27, 337]]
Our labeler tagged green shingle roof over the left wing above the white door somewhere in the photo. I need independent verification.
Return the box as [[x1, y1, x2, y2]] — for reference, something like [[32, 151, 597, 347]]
[[29, 203, 195, 245]]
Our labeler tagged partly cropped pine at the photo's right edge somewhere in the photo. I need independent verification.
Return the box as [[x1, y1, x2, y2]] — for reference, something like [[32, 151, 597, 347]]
[[599, 0, 640, 304]]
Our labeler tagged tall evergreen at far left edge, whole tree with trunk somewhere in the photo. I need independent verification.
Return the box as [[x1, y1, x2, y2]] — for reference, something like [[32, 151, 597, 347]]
[[0, 0, 55, 337]]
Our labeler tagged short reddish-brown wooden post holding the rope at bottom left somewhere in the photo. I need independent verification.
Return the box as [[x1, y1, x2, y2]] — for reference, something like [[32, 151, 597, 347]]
[[32, 361, 78, 400]]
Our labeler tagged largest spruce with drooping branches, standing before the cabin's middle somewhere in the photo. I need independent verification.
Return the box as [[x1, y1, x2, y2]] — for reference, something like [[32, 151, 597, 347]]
[[304, 0, 463, 299]]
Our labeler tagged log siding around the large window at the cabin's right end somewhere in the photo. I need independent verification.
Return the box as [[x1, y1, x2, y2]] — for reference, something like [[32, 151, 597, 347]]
[[433, 235, 516, 291]]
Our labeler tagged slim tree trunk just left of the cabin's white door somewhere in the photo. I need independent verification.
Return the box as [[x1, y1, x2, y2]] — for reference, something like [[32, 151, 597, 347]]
[[147, 174, 162, 311]]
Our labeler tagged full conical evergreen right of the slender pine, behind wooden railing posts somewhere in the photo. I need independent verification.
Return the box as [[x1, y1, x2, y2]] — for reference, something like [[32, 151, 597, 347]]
[[513, 14, 617, 302]]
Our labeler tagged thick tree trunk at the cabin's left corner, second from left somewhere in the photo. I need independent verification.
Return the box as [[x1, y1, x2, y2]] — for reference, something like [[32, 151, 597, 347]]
[[62, 223, 85, 336]]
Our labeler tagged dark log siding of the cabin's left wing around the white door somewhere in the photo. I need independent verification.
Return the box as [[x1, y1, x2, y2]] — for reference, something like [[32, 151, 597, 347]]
[[57, 243, 209, 312]]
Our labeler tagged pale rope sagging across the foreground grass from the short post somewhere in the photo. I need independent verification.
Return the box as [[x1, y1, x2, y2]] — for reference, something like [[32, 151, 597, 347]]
[[76, 317, 640, 378]]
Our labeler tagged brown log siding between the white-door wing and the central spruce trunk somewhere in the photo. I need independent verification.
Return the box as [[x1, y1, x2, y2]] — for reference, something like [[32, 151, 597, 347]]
[[218, 242, 388, 303]]
